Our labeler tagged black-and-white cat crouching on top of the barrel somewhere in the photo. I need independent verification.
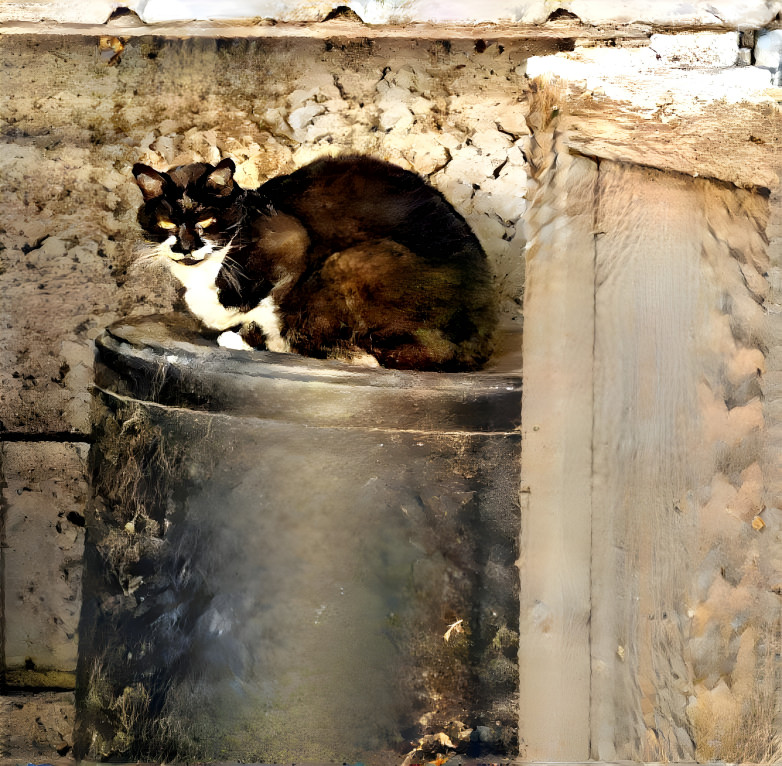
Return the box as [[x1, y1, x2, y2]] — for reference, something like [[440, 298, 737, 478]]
[[133, 156, 496, 371]]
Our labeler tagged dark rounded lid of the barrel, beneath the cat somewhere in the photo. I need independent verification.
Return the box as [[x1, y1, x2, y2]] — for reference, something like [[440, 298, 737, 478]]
[[96, 314, 521, 433]]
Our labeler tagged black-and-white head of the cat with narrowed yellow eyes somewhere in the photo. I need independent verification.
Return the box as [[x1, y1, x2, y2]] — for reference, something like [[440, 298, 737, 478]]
[[133, 159, 244, 264]]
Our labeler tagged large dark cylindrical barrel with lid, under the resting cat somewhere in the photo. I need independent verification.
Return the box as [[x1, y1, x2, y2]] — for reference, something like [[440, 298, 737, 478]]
[[76, 317, 521, 763]]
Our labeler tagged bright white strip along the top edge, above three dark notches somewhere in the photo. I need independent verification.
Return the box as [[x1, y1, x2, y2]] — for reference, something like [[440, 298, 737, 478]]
[[0, 0, 782, 27]]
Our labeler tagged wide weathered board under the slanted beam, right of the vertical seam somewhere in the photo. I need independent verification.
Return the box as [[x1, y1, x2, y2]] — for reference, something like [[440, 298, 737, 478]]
[[591, 162, 782, 762]]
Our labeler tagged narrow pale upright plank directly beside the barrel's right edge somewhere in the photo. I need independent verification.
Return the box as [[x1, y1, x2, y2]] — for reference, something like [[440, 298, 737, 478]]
[[519, 126, 597, 761]]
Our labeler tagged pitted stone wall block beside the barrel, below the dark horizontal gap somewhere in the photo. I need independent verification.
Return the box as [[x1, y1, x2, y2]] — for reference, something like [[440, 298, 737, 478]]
[[0, 442, 87, 687]]
